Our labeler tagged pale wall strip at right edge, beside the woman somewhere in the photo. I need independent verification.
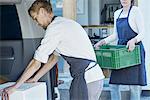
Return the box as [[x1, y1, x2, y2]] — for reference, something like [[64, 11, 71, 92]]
[[138, 0, 150, 84]]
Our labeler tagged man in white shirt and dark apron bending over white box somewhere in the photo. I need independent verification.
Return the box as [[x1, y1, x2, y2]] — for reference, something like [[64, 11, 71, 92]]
[[0, 0, 104, 100]]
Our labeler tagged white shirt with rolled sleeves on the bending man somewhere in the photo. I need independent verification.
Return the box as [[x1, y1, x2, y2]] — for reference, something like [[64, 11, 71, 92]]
[[34, 17, 104, 83]]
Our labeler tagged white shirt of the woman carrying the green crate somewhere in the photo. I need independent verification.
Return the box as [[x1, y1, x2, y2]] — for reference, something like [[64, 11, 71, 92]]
[[104, 6, 145, 43]]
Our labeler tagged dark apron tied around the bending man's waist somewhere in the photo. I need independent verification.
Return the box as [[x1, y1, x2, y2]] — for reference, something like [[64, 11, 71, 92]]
[[62, 55, 97, 100]]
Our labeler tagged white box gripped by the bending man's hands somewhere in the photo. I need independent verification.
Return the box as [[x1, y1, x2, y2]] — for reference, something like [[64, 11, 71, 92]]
[[0, 82, 47, 100]]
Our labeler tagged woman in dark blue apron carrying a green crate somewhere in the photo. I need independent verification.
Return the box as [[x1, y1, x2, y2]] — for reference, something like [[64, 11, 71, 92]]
[[95, 0, 147, 100]]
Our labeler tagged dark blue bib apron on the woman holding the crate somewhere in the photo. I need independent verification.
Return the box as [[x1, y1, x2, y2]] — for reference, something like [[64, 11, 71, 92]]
[[109, 6, 147, 86]]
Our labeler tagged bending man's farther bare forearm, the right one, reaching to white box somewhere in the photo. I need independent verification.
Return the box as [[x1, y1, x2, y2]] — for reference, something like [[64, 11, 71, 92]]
[[27, 55, 58, 82]]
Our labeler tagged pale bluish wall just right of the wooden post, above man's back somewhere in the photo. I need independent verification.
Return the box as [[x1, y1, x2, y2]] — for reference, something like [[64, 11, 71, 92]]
[[76, 0, 119, 25]]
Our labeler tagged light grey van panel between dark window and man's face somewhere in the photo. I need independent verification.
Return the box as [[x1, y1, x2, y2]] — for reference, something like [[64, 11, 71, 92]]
[[16, 0, 44, 39]]
